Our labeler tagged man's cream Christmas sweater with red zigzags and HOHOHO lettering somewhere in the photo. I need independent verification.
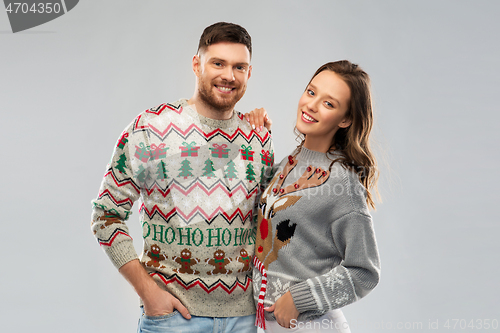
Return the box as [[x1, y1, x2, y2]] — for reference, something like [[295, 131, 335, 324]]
[[92, 100, 274, 317]]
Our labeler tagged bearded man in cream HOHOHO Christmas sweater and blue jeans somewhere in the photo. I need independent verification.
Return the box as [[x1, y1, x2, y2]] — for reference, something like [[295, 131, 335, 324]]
[[92, 22, 274, 332]]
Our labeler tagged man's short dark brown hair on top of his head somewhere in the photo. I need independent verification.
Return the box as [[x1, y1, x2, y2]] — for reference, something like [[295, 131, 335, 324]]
[[198, 22, 252, 57]]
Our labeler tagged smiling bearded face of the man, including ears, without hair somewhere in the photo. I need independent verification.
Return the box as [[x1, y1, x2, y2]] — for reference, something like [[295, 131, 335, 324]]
[[193, 42, 252, 111]]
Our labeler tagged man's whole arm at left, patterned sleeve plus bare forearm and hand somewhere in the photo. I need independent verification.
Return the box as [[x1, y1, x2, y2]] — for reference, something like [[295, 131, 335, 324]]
[[92, 115, 191, 319]]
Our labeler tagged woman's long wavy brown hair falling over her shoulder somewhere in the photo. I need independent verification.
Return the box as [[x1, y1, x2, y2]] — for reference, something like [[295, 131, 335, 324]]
[[296, 60, 379, 208]]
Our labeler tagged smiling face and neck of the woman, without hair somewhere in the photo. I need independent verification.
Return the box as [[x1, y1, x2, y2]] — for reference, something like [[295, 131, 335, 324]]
[[297, 70, 351, 151]]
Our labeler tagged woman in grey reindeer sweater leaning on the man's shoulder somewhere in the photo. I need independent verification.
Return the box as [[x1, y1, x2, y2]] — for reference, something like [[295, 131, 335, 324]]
[[246, 60, 380, 332]]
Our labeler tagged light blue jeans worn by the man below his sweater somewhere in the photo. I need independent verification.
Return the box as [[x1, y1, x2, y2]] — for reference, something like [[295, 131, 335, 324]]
[[137, 308, 257, 333]]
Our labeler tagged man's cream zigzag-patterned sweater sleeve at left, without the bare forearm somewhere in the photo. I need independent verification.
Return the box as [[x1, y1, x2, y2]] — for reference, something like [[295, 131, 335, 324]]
[[91, 119, 147, 268]]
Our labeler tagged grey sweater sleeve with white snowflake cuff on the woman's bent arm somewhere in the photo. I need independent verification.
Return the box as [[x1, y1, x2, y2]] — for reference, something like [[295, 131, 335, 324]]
[[290, 212, 380, 315]]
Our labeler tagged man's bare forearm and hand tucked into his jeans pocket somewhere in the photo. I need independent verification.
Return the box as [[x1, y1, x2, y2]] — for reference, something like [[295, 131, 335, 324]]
[[119, 259, 191, 319]]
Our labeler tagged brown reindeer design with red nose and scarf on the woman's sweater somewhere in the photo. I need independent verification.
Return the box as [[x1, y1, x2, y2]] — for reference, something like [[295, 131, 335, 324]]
[[253, 155, 330, 329]]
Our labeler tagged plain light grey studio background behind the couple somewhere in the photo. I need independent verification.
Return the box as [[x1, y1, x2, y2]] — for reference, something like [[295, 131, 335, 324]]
[[0, 0, 500, 333]]
